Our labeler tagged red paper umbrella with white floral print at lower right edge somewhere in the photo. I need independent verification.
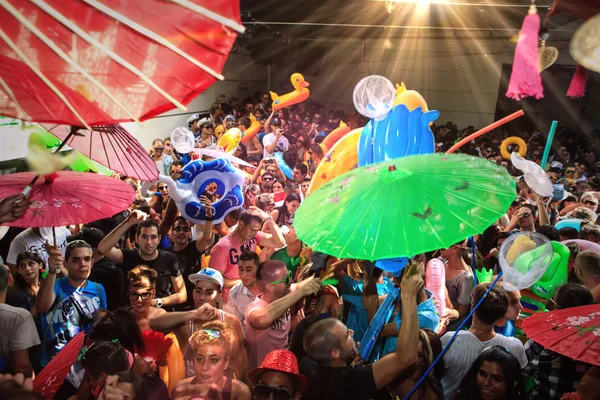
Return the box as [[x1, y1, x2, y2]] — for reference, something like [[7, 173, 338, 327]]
[[522, 304, 600, 366]]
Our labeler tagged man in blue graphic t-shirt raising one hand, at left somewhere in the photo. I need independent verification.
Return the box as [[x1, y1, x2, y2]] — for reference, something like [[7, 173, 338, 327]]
[[35, 240, 106, 366]]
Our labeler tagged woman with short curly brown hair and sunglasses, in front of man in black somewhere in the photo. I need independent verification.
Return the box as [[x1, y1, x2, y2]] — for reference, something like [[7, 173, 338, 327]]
[[127, 265, 166, 331]]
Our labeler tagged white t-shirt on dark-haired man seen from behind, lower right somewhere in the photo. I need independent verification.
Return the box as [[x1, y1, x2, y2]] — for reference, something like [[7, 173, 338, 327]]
[[441, 331, 527, 400]]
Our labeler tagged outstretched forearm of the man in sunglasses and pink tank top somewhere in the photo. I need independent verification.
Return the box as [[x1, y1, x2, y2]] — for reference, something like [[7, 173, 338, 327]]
[[248, 277, 321, 330]]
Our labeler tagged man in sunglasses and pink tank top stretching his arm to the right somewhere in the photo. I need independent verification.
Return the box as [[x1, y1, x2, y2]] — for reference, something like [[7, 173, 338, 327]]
[[244, 260, 321, 369]]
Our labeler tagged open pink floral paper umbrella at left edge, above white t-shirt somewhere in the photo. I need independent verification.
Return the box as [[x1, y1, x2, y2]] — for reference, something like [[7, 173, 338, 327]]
[[0, 171, 135, 228]]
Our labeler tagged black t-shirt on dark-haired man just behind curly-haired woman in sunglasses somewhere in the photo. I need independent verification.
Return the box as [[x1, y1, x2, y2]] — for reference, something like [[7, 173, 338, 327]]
[[121, 249, 181, 297]]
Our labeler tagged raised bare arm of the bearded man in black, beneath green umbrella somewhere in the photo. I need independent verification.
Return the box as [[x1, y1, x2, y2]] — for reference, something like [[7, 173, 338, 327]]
[[373, 264, 423, 389]]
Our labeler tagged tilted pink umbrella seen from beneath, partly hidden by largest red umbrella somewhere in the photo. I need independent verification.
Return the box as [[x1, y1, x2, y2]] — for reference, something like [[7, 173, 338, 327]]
[[42, 124, 159, 182]]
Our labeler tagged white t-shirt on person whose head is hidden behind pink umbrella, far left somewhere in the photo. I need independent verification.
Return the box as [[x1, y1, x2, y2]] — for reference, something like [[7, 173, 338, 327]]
[[6, 227, 71, 264]]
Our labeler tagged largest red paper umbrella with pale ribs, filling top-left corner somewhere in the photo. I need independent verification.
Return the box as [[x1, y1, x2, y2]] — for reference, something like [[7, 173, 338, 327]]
[[0, 0, 244, 128]]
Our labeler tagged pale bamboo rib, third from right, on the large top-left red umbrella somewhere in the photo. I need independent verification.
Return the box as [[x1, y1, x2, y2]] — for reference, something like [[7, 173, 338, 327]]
[[29, 0, 188, 111]]
